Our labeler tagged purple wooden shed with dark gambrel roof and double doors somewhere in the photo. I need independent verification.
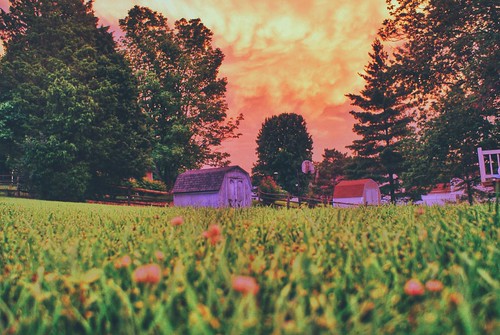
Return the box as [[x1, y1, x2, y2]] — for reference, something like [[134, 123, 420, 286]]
[[173, 166, 252, 207]]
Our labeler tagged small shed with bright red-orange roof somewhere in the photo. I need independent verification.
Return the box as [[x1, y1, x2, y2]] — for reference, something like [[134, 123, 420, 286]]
[[333, 179, 380, 207]]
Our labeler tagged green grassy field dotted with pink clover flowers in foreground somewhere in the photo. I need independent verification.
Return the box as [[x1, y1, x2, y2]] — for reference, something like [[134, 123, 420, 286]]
[[0, 198, 500, 334]]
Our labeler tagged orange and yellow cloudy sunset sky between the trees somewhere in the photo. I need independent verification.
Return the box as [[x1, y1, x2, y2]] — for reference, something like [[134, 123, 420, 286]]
[[0, 0, 388, 172]]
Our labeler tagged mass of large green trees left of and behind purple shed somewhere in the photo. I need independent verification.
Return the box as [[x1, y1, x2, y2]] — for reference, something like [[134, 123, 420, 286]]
[[0, 0, 242, 200]]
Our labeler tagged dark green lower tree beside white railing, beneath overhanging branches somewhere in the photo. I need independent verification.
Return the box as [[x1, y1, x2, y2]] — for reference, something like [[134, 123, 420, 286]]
[[404, 87, 499, 204]]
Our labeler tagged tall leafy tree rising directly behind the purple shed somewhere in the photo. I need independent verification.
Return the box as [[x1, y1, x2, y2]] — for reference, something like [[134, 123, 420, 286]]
[[120, 6, 242, 187]]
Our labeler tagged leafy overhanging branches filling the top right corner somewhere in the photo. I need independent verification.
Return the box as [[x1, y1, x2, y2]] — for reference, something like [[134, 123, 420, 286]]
[[381, 0, 500, 115]]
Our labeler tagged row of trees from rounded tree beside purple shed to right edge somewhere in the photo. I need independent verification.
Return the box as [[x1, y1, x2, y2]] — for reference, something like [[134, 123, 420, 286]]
[[253, 0, 500, 202]]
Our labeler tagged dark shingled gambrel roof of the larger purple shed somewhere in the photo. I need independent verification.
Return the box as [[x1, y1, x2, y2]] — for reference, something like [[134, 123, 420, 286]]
[[173, 165, 248, 193]]
